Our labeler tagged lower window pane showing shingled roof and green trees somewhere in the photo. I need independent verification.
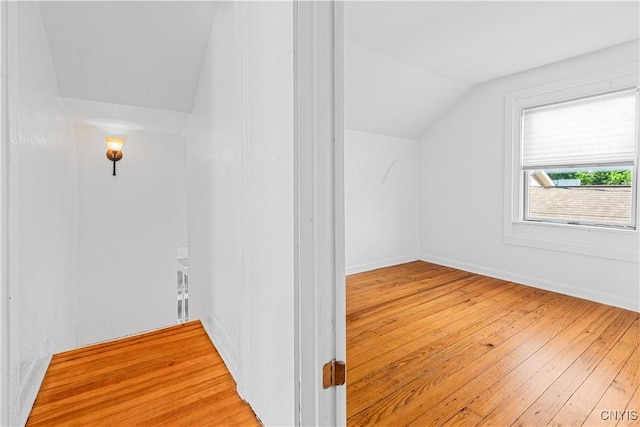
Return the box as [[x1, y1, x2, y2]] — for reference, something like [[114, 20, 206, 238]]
[[525, 167, 633, 226]]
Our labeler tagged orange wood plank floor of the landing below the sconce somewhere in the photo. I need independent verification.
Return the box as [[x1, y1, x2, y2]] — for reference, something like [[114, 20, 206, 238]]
[[27, 321, 260, 426]]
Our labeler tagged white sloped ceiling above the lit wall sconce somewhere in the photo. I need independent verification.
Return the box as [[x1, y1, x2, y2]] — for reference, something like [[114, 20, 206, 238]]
[[40, 1, 217, 113]]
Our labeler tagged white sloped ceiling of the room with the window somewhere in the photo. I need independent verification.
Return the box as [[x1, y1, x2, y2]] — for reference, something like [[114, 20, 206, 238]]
[[345, 1, 640, 138]]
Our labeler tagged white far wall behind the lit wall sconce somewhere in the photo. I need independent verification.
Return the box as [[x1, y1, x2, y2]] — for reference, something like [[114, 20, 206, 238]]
[[75, 125, 187, 345]]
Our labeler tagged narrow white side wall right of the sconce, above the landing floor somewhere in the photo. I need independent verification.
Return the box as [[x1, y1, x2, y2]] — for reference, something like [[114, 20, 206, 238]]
[[187, 3, 244, 382]]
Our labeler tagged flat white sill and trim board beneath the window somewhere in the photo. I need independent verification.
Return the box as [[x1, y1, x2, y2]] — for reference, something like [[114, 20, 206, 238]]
[[504, 221, 640, 264]]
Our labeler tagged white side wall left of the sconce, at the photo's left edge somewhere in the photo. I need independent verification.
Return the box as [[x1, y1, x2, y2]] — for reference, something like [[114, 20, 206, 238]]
[[3, 2, 76, 425]]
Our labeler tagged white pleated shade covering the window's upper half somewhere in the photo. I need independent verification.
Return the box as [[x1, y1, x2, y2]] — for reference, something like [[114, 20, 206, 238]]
[[522, 91, 637, 169]]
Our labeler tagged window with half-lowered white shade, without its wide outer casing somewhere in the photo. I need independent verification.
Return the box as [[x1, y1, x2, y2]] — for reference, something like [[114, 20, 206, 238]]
[[520, 89, 638, 229]]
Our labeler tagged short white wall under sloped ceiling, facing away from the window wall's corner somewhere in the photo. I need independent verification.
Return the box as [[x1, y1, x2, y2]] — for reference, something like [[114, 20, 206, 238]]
[[344, 130, 418, 274]]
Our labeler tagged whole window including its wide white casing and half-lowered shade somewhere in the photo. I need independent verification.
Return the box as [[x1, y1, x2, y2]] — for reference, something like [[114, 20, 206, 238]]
[[504, 66, 640, 263]]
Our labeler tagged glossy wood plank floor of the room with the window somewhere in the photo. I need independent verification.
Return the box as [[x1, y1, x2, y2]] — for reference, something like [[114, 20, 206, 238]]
[[347, 261, 640, 426]]
